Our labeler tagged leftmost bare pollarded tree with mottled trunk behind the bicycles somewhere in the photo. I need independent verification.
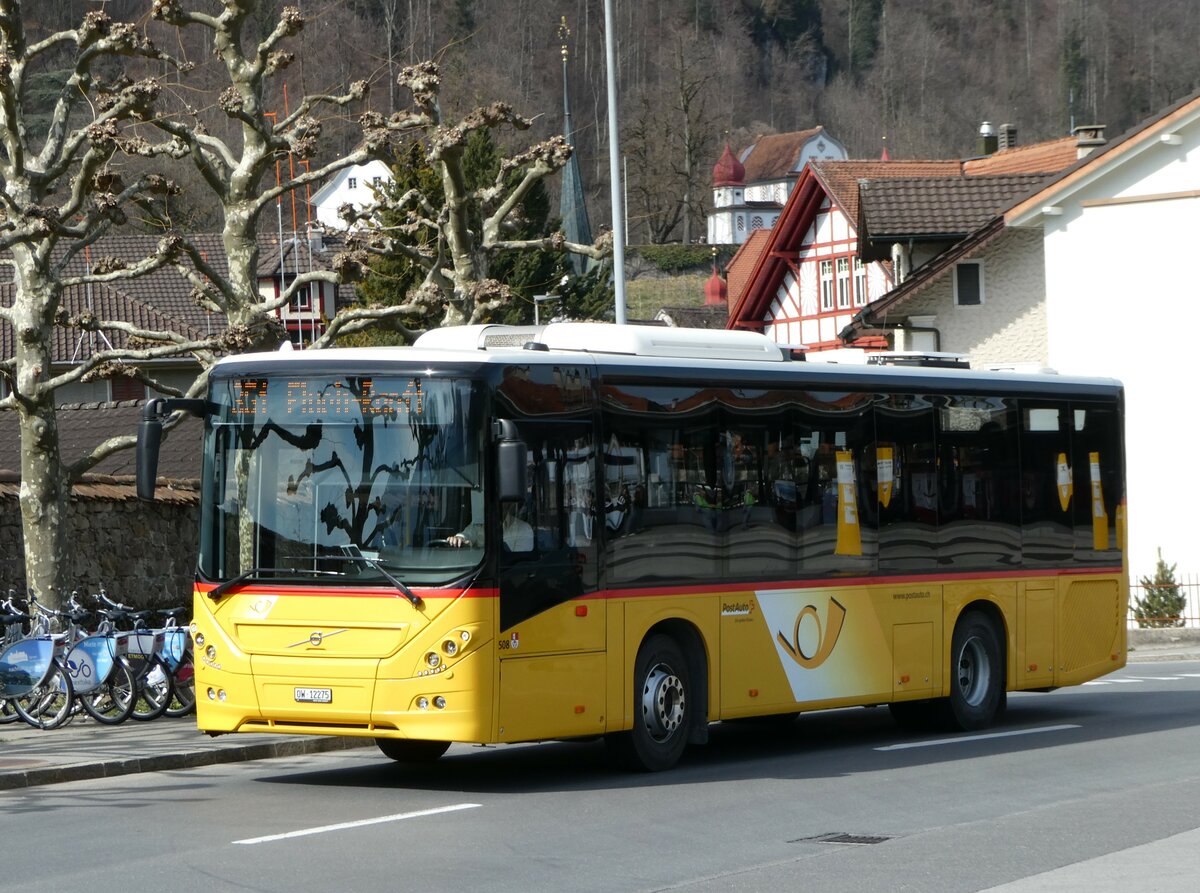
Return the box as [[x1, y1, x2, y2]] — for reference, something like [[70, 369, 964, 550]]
[[0, 0, 200, 604]]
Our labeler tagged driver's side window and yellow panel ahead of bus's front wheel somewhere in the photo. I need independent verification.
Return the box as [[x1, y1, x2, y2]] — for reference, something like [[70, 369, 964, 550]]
[[498, 422, 606, 741]]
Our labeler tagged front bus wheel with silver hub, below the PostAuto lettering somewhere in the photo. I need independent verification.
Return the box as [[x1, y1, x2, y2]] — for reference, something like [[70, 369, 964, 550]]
[[607, 635, 694, 772]]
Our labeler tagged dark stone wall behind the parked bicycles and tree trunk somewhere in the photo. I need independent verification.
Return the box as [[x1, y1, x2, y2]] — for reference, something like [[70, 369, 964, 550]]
[[0, 484, 199, 607]]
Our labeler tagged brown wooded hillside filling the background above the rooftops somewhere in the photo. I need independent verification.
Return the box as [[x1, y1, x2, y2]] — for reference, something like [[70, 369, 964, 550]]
[[18, 0, 1200, 244]]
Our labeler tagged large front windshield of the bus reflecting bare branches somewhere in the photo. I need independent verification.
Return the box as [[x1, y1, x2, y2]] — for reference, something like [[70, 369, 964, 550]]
[[199, 374, 484, 586]]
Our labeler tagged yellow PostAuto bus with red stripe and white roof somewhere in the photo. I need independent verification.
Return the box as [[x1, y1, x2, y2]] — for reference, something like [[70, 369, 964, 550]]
[[138, 323, 1128, 771]]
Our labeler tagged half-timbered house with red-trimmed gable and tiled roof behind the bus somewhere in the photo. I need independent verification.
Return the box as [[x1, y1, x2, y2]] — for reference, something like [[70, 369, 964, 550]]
[[727, 125, 1092, 352]]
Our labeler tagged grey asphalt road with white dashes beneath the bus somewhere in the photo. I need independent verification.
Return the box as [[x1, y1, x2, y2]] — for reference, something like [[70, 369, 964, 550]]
[[0, 661, 1200, 893]]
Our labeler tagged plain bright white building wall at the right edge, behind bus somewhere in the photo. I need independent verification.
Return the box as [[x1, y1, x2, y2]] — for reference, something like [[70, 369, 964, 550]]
[[1044, 145, 1200, 579]]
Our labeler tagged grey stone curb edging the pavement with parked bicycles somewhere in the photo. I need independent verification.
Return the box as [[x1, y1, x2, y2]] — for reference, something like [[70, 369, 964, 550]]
[[0, 736, 374, 791]]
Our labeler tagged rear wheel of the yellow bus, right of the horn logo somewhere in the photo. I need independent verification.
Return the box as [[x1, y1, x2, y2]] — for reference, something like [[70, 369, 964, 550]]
[[946, 611, 1006, 732]]
